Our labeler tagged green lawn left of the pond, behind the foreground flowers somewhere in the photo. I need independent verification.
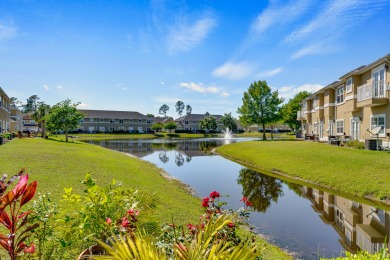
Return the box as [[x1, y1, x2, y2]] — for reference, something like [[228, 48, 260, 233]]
[[0, 138, 289, 259]]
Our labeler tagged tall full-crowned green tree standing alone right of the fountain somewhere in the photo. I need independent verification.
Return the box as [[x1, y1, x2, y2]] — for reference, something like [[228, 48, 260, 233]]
[[237, 80, 283, 140]]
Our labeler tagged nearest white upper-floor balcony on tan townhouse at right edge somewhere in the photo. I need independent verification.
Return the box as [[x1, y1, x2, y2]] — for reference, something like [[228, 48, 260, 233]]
[[357, 80, 388, 107]]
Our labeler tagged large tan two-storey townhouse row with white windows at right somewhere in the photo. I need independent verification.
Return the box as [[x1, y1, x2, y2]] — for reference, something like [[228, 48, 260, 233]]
[[297, 54, 390, 145]]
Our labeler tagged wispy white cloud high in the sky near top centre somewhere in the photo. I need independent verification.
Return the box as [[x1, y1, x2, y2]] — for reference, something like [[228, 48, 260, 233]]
[[167, 16, 217, 54]]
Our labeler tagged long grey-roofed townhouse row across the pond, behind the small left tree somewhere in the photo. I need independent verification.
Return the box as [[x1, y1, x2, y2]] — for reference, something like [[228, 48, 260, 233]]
[[79, 109, 164, 133]]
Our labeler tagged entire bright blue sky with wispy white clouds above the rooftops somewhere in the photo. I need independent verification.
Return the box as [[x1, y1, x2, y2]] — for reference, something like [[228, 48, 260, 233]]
[[0, 0, 390, 118]]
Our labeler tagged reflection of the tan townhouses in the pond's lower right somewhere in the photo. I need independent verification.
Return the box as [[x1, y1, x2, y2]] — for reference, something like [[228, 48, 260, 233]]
[[302, 187, 390, 253]]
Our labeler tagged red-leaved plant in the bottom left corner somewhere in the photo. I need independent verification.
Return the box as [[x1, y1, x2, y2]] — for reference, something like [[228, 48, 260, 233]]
[[0, 169, 38, 260]]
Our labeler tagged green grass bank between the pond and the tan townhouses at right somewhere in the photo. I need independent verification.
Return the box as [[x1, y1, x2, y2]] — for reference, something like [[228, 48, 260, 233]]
[[217, 141, 390, 205]]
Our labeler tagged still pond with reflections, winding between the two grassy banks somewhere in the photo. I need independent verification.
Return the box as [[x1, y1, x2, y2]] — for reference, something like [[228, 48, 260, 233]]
[[89, 138, 390, 259]]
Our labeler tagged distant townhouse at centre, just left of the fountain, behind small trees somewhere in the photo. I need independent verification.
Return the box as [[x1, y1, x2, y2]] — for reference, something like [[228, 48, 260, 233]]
[[175, 113, 225, 132]]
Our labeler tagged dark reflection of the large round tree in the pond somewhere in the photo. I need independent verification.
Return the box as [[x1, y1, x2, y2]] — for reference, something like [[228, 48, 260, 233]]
[[237, 169, 283, 212]]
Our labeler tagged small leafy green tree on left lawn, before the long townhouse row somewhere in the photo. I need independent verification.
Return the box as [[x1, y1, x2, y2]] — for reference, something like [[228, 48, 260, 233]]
[[46, 99, 84, 142]]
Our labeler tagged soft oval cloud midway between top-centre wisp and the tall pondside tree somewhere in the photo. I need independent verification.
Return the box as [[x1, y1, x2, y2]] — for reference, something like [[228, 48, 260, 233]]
[[213, 61, 255, 80]]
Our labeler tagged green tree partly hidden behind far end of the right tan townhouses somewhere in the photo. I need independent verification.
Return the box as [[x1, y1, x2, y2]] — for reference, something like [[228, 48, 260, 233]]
[[281, 91, 311, 132]]
